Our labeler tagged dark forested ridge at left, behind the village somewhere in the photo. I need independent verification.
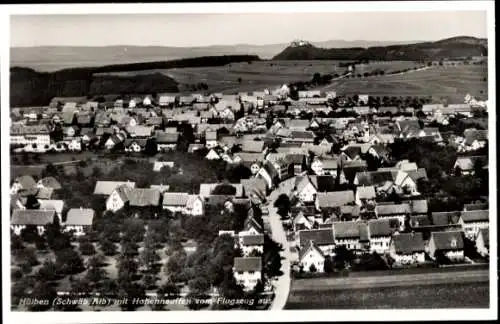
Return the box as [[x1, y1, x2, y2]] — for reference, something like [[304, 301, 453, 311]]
[[10, 55, 259, 107]]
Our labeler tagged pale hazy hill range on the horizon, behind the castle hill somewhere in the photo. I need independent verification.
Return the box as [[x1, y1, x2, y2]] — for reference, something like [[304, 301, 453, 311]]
[[10, 40, 422, 72]]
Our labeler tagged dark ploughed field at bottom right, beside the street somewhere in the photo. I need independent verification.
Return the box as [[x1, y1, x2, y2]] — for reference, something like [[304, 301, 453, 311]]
[[285, 268, 489, 309]]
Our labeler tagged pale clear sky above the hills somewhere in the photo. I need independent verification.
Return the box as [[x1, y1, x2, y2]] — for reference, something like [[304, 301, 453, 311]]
[[10, 11, 487, 47]]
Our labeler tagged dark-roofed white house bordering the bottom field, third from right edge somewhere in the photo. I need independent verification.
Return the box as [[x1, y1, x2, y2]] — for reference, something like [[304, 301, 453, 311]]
[[389, 232, 425, 267]]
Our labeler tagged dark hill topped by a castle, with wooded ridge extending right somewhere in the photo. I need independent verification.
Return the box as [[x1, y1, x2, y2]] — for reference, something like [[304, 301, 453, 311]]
[[273, 36, 488, 61]]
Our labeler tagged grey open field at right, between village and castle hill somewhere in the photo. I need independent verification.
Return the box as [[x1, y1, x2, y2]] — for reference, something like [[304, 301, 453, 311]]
[[322, 65, 488, 103]]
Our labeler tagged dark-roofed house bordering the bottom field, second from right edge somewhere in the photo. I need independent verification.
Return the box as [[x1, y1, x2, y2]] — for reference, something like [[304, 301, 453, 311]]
[[427, 231, 464, 262]]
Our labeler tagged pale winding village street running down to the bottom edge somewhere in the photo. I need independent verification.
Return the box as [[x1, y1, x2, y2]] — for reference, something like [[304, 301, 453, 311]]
[[268, 177, 295, 310]]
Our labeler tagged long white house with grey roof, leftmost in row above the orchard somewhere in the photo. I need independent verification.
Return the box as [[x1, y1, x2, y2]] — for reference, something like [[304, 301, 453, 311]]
[[10, 209, 56, 236]]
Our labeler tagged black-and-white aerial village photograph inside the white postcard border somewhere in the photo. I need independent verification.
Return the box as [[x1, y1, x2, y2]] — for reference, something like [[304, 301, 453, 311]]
[[6, 7, 496, 312]]
